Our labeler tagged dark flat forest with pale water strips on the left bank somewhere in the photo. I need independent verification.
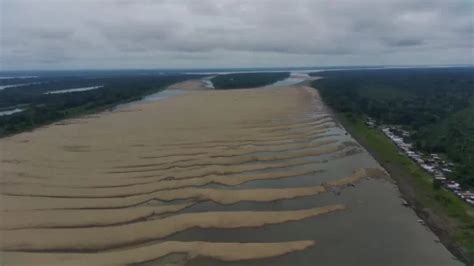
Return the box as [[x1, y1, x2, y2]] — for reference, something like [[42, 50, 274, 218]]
[[0, 73, 196, 136]]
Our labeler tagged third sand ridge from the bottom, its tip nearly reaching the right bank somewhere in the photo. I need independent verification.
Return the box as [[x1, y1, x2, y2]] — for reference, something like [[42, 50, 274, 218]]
[[0, 169, 384, 229]]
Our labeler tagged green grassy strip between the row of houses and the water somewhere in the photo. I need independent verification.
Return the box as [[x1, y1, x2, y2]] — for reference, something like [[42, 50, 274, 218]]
[[338, 113, 474, 265]]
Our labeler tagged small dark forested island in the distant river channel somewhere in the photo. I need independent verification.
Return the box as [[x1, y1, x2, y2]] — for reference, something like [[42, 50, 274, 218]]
[[211, 72, 290, 90]]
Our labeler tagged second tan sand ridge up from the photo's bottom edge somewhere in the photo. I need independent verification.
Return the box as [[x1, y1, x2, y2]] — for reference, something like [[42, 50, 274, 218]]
[[1, 204, 345, 251]]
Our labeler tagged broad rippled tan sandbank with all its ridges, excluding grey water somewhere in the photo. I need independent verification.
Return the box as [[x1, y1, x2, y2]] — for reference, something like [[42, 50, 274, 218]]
[[0, 81, 385, 265]]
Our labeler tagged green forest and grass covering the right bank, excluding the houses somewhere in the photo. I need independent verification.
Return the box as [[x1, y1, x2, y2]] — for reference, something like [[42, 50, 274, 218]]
[[312, 68, 474, 264]]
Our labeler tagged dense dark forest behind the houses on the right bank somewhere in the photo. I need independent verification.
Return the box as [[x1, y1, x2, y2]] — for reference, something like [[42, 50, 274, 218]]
[[312, 67, 474, 187]]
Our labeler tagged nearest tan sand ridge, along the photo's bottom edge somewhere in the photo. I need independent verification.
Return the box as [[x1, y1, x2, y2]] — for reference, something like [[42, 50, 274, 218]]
[[2, 240, 315, 266]]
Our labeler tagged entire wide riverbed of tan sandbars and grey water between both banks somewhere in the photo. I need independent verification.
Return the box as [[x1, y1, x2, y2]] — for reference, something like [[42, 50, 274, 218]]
[[0, 81, 461, 266]]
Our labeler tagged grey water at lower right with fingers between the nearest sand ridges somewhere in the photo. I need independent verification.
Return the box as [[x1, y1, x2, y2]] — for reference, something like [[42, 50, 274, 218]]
[[182, 180, 461, 265]]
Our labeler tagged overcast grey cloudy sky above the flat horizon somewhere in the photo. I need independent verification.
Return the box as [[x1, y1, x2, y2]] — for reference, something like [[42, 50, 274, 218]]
[[0, 0, 474, 70]]
